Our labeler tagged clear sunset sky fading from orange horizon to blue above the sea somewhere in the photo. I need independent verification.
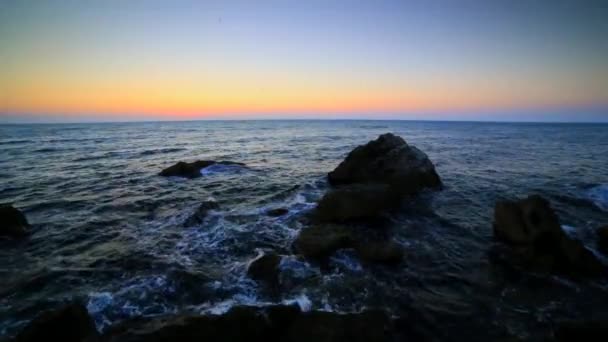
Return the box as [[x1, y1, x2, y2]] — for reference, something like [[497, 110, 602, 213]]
[[0, 0, 608, 122]]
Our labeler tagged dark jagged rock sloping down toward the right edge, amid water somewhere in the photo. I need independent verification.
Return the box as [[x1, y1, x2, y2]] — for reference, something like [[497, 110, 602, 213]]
[[494, 195, 606, 276]]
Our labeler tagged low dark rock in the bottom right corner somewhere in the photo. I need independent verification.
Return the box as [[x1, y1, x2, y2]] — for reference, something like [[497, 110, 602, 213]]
[[554, 320, 608, 342]]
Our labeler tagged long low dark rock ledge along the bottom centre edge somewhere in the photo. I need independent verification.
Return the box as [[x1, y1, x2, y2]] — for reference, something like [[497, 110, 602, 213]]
[[92, 305, 398, 342]]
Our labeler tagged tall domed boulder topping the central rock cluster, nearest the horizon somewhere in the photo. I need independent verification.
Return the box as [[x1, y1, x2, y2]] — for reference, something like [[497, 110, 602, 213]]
[[328, 133, 441, 195]]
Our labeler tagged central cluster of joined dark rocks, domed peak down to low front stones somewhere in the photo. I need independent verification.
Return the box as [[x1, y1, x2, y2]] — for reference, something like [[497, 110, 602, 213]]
[[294, 133, 441, 264]]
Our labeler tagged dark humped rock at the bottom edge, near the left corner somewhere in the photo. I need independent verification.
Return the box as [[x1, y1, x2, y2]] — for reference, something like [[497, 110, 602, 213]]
[[15, 303, 97, 342]]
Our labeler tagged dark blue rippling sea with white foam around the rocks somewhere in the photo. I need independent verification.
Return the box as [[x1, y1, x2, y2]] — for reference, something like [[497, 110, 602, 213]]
[[0, 121, 608, 340]]
